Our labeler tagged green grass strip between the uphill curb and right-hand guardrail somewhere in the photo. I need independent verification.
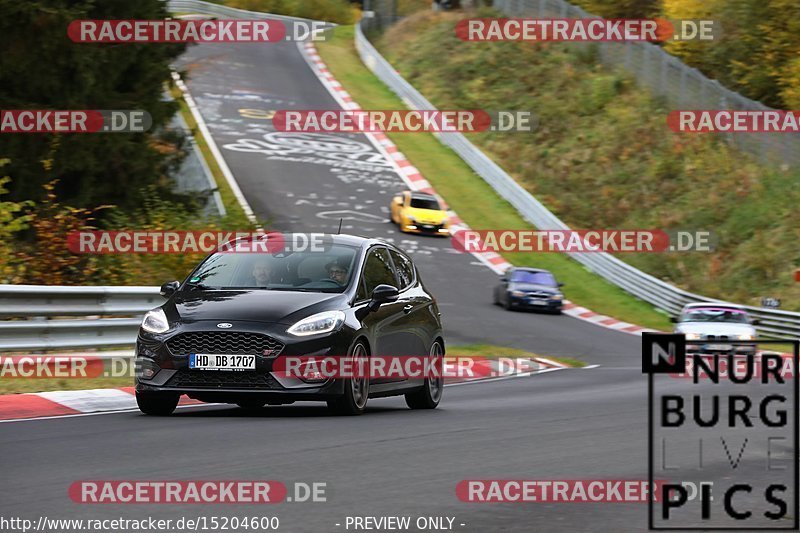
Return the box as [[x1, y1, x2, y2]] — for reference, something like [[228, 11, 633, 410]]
[[317, 26, 671, 330]]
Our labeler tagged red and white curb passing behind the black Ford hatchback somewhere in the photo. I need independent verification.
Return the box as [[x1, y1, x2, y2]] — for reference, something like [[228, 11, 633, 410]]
[[0, 357, 567, 422]]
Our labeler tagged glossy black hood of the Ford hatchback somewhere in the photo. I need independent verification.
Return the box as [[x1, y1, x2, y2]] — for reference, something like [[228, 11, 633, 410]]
[[164, 290, 347, 324]]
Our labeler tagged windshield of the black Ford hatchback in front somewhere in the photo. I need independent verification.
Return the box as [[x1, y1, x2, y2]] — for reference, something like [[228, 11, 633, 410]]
[[184, 244, 358, 292]]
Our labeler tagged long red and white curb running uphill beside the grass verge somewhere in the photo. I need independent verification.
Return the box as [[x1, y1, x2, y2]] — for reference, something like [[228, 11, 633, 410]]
[[298, 42, 655, 335]]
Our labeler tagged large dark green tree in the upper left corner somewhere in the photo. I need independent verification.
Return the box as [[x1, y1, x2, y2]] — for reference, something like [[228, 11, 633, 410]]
[[0, 0, 185, 212]]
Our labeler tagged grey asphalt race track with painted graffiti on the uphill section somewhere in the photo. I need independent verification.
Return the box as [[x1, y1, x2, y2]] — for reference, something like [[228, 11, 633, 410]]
[[0, 32, 788, 533]]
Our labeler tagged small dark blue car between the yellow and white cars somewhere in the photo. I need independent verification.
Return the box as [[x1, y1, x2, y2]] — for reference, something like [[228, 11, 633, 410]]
[[494, 267, 564, 314]]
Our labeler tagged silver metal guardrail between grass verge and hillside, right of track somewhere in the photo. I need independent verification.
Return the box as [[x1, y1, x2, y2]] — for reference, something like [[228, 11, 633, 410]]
[[355, 20, 800, 339]]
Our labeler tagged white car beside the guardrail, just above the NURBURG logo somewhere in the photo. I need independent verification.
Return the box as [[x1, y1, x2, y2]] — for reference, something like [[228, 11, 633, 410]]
[[673, 303, 758, 353]]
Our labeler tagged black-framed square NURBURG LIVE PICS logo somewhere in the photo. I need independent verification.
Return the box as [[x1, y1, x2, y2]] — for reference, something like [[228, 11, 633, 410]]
[[642, 333, 800, 531]]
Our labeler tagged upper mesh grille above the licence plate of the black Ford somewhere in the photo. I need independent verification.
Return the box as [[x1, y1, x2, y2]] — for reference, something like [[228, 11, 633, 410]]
[[167, 331, 283, 357]]
